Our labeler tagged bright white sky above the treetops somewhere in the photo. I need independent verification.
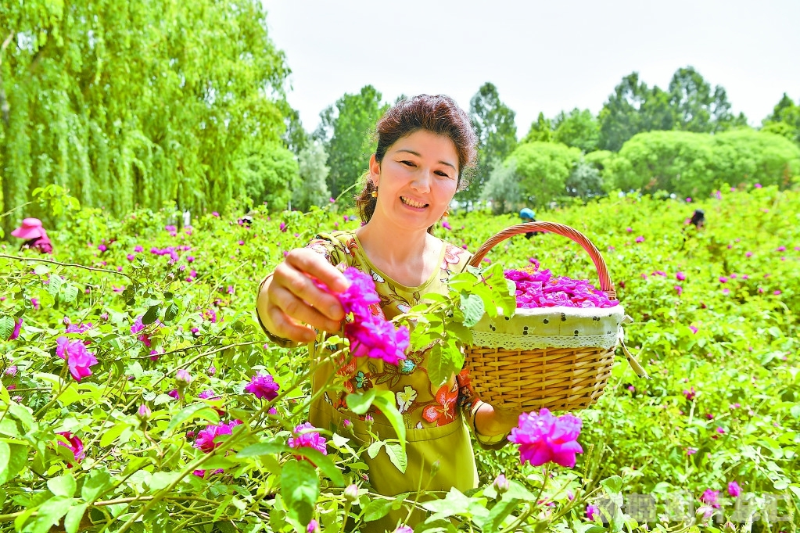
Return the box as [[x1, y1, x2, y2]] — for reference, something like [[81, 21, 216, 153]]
[[262, 0, 800, 137]]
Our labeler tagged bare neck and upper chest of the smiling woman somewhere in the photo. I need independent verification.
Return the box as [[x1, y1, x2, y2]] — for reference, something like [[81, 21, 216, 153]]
[[356, 218, 443, 287]]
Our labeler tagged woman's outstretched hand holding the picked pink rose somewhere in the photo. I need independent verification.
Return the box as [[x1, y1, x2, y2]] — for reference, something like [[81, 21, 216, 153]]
[[256, 248, 349, 342]]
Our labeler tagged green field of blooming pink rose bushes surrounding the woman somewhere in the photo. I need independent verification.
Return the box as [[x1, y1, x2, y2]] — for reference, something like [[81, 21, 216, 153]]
[[0, 186, 800, 533]]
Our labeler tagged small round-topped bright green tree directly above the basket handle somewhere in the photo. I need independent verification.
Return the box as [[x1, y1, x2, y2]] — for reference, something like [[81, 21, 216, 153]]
[[509, 142, 581, 206]]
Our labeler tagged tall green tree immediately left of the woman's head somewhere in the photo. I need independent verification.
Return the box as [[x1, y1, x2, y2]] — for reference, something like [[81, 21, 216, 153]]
[[314, 85, 388, 197]]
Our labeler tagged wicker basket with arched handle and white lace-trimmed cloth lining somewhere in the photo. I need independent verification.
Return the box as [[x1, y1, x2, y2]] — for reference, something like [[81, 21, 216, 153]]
[[466, 222, 640, 412]]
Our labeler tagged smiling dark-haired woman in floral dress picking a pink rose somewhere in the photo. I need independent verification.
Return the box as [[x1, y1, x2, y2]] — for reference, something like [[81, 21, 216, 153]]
[[257, 95, 517, 531]]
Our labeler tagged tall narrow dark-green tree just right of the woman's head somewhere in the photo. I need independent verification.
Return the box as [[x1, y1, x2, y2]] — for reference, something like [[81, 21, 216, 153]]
[[459, 82, 517, 204]]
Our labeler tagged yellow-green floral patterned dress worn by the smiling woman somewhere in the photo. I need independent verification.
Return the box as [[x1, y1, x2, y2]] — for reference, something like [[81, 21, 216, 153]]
[[260, 231, 505, 531]]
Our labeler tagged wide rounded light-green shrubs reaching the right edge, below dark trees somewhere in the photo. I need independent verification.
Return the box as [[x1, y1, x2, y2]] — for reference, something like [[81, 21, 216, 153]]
[[604, 130, 800, 197]]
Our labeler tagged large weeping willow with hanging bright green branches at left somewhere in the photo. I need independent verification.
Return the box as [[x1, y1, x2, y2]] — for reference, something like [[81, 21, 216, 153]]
[[0, 0, 296, 231]]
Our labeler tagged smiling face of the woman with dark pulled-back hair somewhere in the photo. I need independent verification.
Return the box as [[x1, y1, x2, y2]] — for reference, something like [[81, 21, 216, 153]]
[[370, 130, 458, 230]]
